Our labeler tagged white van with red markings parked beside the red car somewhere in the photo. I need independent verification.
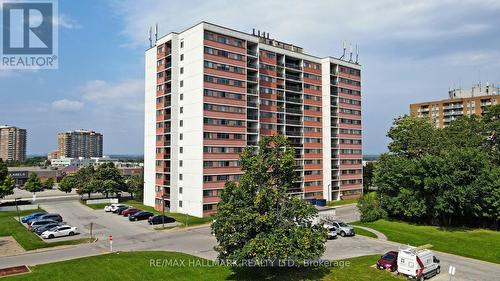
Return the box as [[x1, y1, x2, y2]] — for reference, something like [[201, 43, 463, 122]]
[[398, 246, 441, 281]]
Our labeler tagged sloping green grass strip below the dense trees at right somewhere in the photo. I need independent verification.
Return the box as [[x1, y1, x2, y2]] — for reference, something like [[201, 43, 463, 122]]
[[354, 220, 500, 263]]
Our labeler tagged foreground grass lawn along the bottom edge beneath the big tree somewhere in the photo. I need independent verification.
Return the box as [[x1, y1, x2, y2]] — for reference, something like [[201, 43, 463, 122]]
[[2, 252, 404, 281]]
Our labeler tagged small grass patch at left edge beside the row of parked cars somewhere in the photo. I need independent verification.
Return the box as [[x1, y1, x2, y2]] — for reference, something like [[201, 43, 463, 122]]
[[0, 209, 94, 251]]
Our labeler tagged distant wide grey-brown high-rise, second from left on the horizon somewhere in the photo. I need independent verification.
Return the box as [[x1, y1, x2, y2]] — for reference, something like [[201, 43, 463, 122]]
[[57, 130, 103, 158]]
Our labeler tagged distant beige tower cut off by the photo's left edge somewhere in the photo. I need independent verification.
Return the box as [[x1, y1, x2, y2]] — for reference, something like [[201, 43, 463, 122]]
[[0, 125, 26, 161]]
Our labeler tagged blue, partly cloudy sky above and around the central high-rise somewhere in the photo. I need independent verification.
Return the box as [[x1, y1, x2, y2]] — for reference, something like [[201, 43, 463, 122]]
[[0, 0, 500, 154]]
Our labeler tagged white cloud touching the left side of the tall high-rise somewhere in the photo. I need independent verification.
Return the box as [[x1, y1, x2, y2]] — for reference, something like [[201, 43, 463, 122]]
[[80, 79, 144, 112]]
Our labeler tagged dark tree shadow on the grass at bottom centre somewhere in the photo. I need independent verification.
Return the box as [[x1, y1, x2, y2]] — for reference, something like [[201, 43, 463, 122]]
[[226, 267, 332, 281]]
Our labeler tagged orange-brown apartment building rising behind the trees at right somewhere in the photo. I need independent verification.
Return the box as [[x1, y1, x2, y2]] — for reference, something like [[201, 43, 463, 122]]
[[410, 84, 500, 128]]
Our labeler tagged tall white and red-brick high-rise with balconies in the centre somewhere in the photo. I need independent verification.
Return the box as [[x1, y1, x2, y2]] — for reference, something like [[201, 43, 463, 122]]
[[144, 22, 363, 217]]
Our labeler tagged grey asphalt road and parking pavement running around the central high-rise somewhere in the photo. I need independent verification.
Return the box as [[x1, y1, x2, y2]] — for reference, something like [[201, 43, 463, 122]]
[[0, 201, 500, 280]]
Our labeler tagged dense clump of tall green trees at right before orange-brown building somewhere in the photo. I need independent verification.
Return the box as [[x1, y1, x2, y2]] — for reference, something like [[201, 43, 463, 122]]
[[374, 110, 500, 228]]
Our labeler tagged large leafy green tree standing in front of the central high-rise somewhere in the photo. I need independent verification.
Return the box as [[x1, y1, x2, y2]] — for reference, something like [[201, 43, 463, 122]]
[[212, 135, 326, 262]]
